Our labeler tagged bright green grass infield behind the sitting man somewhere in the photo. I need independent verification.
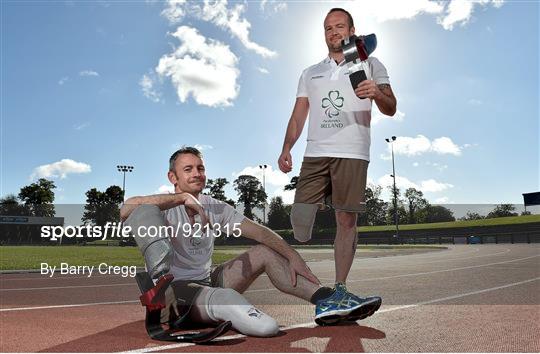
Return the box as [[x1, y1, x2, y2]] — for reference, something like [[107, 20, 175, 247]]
[[0, 246, 236, 270]]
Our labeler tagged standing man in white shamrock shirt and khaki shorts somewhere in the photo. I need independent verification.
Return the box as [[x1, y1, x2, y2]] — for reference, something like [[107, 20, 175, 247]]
[[278, 8, 396, 318]]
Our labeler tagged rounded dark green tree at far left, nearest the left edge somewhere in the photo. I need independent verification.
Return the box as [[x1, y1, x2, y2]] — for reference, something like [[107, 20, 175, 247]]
[[19, 178, 56, 217]]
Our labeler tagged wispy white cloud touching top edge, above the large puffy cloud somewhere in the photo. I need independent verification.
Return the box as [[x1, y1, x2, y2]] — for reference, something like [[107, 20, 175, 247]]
[[162, 0, 277, 58]]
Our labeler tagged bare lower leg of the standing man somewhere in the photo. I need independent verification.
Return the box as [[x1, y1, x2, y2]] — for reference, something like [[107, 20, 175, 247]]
[[334, 211, 358, 283]]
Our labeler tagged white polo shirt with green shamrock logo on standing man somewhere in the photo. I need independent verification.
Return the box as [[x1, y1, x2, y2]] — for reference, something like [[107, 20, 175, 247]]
[[296, 57, 390, 161]]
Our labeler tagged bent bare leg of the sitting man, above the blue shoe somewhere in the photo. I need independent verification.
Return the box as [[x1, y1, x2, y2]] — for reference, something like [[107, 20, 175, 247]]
[[223, 245, 320, 301]]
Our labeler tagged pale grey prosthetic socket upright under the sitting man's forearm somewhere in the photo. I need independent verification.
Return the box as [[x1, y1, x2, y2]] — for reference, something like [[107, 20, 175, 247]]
[[125, 205, 174, 279]]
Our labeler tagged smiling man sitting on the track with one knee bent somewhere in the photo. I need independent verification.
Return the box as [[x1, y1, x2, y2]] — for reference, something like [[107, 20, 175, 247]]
[[120, 147, 376, 337]]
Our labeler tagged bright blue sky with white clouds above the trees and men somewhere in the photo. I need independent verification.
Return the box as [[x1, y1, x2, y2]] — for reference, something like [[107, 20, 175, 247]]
[[0, 0, 540, 216]]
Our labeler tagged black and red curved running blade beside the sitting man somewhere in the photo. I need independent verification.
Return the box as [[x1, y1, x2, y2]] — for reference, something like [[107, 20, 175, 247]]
[[135, 272, 232, 344]]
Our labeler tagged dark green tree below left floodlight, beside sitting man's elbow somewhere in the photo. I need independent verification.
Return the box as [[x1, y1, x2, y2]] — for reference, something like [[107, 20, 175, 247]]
[[82, 186, 124, 226]]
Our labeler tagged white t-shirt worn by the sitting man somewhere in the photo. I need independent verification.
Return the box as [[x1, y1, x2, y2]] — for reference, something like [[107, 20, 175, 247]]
[[163, 194, 245, 280]]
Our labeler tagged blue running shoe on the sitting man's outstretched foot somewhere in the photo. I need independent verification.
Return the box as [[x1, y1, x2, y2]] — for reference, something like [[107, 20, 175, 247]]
[[315, 284, 364, 326]]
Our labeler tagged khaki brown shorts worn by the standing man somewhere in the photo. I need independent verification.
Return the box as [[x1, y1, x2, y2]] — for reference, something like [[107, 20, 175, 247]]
[[294, 157, 369, 212]]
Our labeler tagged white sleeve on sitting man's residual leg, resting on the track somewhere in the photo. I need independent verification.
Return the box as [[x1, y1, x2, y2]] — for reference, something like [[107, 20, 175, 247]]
[[202, 288, 279, 337]]
